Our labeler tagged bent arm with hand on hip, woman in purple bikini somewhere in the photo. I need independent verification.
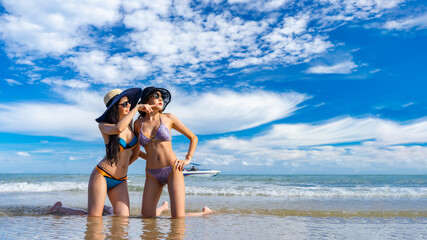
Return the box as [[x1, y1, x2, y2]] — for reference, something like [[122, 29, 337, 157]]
[[168, 113, 199, 171]]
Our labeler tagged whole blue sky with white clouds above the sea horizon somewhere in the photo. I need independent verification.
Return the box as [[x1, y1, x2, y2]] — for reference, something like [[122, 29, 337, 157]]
[[0, 0, 427, 174]]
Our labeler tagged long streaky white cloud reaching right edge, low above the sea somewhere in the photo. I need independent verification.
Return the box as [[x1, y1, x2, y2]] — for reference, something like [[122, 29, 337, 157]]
[[219, 118, 427, 148]]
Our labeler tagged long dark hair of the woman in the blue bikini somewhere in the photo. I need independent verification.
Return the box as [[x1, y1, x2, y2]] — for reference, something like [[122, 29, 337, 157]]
[[105, 102, 119, 166]]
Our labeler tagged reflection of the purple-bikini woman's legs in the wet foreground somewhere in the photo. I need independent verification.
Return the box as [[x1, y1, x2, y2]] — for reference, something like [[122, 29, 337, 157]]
[[141, 218, 186, 239]]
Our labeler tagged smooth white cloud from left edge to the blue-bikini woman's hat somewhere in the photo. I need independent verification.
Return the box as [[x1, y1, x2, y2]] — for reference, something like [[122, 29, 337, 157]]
[[0, 87, 105, 140]]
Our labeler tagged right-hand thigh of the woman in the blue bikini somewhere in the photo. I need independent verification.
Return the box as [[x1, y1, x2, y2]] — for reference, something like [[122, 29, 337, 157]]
[[107, 181, 129, 217]]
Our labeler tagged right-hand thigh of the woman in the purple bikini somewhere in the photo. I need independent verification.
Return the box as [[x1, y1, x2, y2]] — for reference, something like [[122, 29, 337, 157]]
[[168, 169, 185, 218]]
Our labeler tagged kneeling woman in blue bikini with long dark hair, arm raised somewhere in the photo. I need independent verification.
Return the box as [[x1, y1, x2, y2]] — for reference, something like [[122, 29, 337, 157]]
[[48, 88, 168, 217]]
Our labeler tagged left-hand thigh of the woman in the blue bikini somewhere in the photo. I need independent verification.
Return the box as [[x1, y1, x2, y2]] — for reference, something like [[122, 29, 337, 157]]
[[88, 169, 107, 216]]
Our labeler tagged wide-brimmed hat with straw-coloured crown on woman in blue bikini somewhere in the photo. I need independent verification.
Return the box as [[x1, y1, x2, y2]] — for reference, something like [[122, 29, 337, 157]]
[[95, 88, 142, 123]]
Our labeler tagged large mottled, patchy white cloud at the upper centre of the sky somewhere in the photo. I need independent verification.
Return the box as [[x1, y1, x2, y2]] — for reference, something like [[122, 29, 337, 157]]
[[120, 5, 332, 83]]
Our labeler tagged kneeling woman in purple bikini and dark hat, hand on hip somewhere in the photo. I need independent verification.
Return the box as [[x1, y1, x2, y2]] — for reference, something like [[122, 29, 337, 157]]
[[135, 87, 212, 217]]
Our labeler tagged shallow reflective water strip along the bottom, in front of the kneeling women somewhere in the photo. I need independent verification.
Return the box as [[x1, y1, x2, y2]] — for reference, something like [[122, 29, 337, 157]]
[[0, 213, 427, 239]]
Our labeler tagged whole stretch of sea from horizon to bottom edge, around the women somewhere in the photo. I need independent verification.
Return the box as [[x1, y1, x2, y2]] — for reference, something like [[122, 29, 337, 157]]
[[0, 174, 427, 239]]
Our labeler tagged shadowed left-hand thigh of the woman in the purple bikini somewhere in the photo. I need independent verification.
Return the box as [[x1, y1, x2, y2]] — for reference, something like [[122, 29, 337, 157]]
[[141, 172, 163, 218]]
